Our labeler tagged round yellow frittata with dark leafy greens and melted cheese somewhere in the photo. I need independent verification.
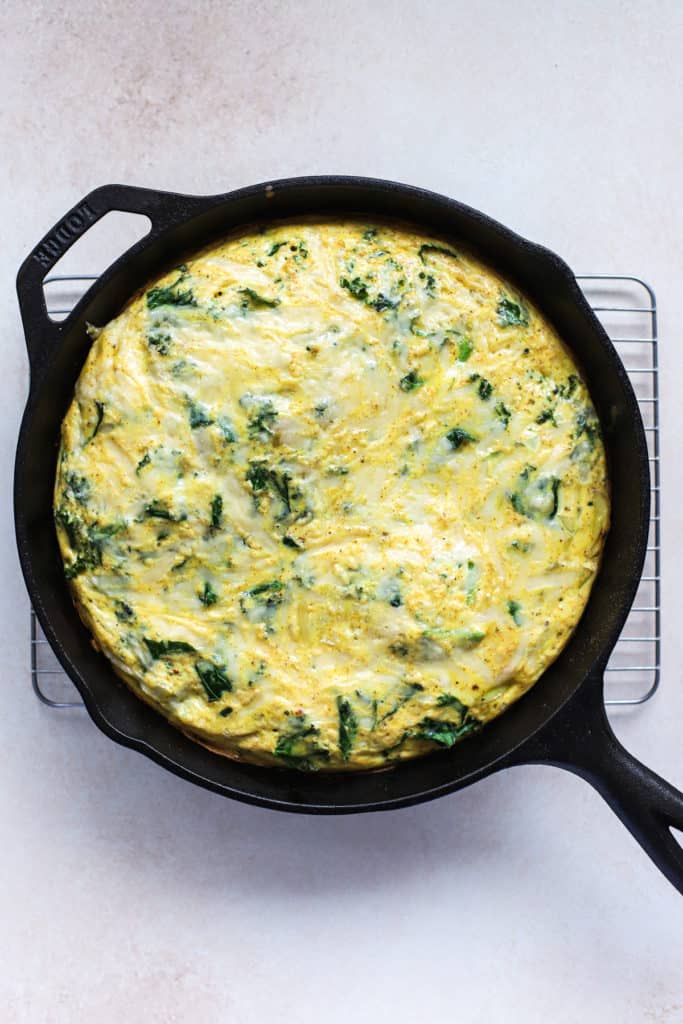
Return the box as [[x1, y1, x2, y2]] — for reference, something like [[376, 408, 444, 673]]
[[54, 219, 609, 770]]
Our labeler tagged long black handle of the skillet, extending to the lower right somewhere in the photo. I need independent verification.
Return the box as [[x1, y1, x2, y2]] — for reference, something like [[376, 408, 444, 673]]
[[508, 667, 683, 894]]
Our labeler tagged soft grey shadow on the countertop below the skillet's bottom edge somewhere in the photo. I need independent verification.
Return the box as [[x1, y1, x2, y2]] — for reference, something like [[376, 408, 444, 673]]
[[44, 718, 655, 902]]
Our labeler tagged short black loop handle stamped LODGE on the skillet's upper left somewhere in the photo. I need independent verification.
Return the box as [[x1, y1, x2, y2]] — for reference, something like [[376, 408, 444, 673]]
[[16, 184, 200, 379]]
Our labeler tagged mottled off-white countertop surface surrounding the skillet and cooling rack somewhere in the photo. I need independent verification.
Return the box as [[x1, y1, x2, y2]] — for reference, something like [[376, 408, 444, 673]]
[[0, 0, 683, 1024]]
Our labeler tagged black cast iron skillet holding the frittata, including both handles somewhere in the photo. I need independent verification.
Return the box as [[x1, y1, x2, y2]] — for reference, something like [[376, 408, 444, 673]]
[[14, 177, 683, 892]]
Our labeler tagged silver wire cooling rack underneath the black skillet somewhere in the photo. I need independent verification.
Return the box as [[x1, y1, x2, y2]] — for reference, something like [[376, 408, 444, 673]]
[[31, 273, 661, 709]]
